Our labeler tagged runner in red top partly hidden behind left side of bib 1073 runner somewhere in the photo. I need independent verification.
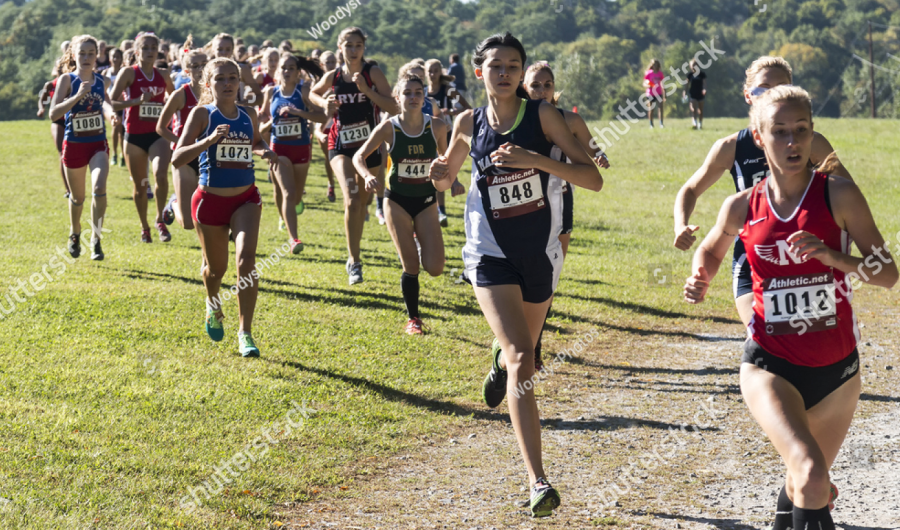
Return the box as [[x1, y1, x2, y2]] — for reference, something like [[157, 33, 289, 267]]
[[156, 36, 207, 230]]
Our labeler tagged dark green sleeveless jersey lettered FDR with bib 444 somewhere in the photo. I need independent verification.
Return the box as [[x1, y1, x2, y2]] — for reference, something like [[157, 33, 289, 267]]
[[387, 115, 437, 197]]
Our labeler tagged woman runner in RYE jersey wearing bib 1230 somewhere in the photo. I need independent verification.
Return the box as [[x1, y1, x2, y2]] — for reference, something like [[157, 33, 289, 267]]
[[310, 27, 399, 285]]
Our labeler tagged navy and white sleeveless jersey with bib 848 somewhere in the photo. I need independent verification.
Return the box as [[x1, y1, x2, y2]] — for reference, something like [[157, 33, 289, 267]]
[[463, 100, 562, 261]]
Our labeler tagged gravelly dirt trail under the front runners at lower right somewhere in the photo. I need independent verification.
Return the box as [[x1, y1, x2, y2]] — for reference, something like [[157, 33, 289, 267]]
[[276, 296, 900, 530]]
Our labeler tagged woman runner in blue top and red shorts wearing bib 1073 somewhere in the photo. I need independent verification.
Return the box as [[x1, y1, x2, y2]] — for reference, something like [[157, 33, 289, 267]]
[[172, 57, 278, 357]]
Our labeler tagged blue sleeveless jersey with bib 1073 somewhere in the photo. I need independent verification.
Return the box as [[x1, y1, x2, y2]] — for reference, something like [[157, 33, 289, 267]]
[[200, 105, 255, 188]]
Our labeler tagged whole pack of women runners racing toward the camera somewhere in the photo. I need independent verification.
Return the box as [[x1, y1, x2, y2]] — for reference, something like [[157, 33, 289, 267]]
[[42, 27, 898, 530]]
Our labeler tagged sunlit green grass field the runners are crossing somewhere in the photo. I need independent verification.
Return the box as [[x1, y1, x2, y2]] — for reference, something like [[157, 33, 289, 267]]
[[0, 119, 900, 529]]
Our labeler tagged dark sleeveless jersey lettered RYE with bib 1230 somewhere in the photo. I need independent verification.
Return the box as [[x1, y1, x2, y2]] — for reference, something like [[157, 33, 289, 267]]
[[328, 63, 378, 151]]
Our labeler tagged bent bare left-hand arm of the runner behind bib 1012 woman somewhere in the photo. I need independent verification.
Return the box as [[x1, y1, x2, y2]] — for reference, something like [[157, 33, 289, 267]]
[[674, 135, 737, 250]]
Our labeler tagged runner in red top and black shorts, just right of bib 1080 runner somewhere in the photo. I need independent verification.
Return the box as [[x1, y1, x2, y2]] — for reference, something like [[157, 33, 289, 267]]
[[111, 33, 175, 243]]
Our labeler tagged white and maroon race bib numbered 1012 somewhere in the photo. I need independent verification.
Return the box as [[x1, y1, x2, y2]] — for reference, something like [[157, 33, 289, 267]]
[[763, 272, 837, 335]]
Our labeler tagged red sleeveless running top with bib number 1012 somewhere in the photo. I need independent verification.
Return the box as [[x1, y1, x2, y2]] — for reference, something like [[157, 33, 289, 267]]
[[740, 172, 859, 366]]
